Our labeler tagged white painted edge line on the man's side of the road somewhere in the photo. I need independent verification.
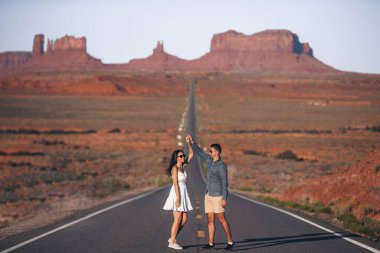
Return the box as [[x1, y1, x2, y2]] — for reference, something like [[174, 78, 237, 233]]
[[232, 192, 380, 253]]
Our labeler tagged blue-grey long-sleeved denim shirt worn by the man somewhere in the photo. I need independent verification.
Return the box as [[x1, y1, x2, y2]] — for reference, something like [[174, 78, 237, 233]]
[[191, 143, 228, 200]]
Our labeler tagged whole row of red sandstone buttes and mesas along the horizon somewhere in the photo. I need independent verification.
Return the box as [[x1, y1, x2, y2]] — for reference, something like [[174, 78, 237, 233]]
[[0, 30, 338, 73]]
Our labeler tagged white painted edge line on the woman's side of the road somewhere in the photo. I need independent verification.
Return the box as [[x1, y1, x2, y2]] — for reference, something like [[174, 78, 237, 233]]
[[0, 186, 167, 253]]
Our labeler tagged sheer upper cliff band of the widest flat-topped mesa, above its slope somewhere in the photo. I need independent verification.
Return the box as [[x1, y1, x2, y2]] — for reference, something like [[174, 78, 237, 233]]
[[211, 30, 313, 55]]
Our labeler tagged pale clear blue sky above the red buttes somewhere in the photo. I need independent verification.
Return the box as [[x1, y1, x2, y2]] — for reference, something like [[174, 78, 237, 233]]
[[0, 0, 380, 73]]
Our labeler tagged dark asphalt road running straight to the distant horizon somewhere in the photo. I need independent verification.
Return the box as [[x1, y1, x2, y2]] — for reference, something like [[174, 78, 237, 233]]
[[0, 80, 380, 253]]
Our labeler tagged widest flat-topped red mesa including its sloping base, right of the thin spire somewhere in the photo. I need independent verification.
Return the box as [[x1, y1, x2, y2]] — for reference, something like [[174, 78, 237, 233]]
[[197, 30, 337, 73]]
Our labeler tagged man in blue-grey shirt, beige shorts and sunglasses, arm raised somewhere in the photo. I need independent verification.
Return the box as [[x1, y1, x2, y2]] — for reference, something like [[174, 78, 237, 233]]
[[188, 135, 234, 250]]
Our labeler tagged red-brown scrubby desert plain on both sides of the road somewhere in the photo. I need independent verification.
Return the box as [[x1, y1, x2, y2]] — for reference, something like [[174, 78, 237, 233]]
[[0, 73, 380, 238]]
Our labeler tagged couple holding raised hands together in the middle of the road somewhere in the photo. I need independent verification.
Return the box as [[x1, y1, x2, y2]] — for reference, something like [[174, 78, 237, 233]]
[[164, 135, 234, 250]]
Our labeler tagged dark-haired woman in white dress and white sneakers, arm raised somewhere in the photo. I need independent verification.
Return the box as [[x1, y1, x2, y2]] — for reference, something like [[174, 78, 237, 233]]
[[164, 137, 193, 250]]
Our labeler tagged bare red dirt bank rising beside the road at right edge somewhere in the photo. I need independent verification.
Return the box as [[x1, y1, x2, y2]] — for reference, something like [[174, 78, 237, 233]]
[[284, 150, 380, 220]]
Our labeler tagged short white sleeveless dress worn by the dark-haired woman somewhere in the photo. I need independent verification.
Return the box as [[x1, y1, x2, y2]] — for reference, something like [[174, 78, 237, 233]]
[[164, 170, 193, 212]]
